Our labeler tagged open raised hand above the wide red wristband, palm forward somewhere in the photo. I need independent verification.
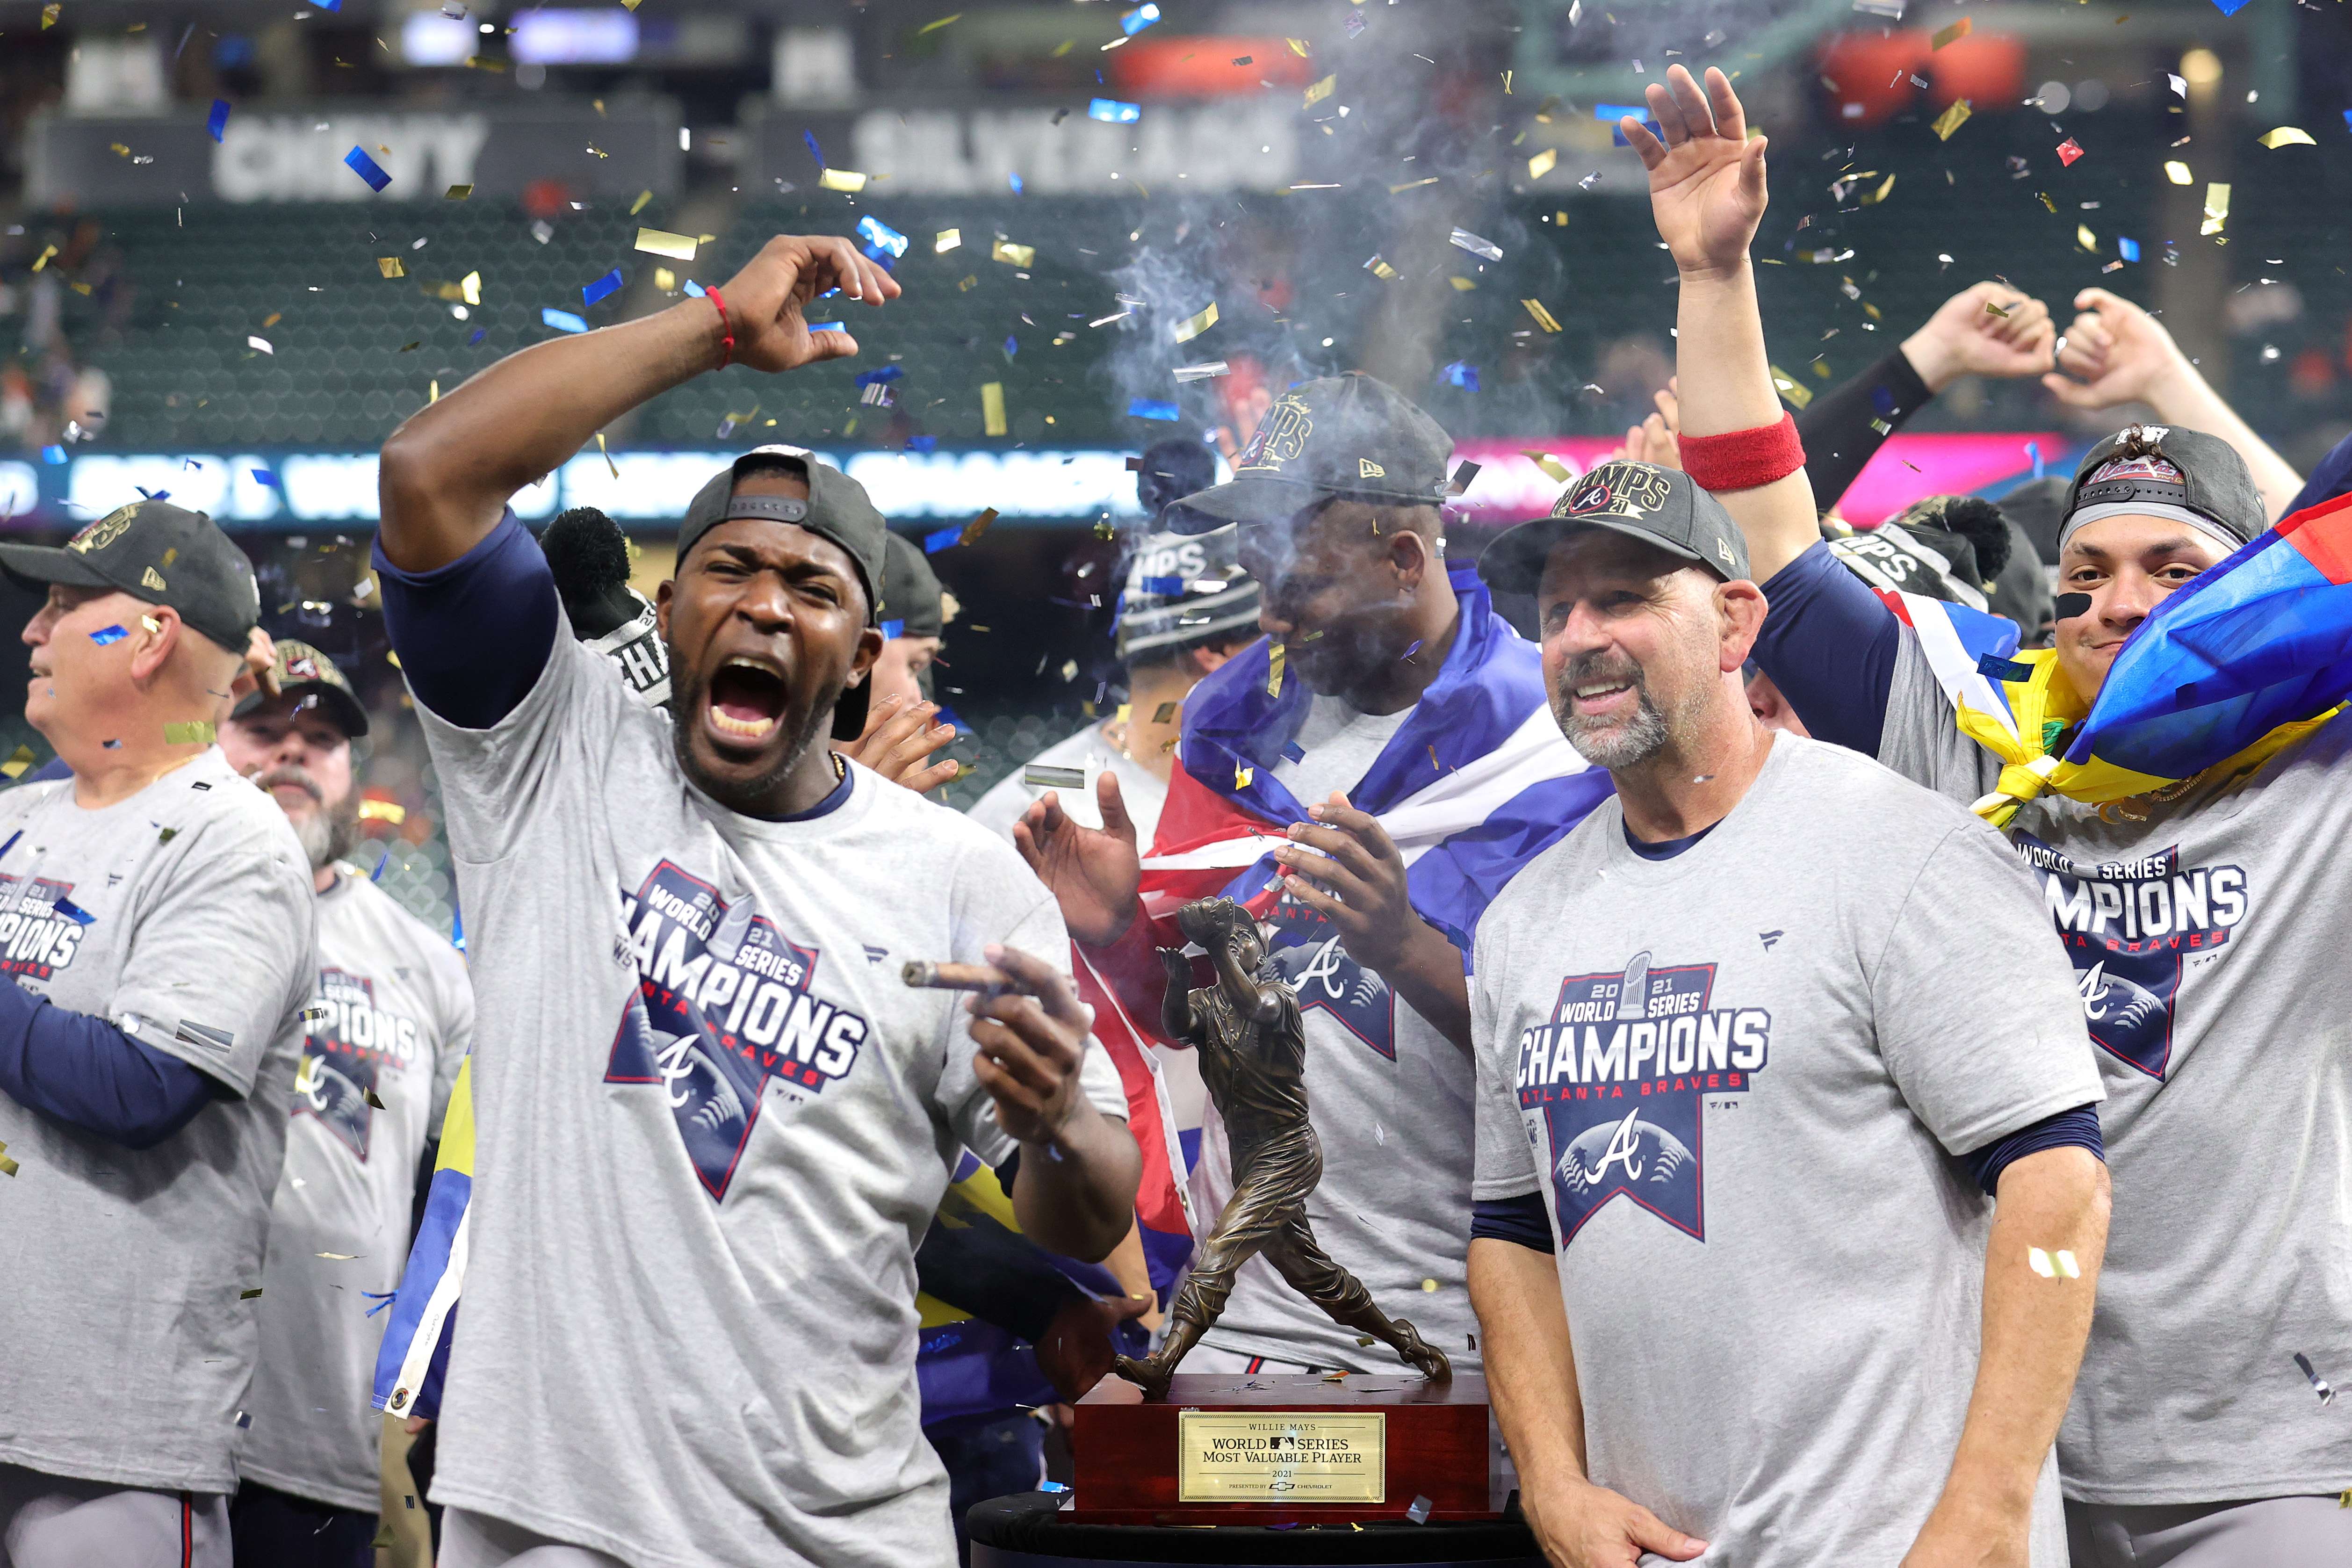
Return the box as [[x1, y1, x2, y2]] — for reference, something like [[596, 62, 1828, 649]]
[[1618, 66, 1767, 275]]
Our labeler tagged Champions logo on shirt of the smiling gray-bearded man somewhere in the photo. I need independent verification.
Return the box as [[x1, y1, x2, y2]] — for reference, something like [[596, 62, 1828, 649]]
[[1515, 952, 1771, 1248]]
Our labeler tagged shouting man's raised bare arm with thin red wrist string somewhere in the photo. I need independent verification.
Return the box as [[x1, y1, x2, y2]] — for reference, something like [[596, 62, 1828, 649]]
[[379, 235, 898, 571]]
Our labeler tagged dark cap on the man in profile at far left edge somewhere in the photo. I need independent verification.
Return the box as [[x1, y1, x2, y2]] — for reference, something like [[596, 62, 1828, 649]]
[[0, 501, 261, 654]]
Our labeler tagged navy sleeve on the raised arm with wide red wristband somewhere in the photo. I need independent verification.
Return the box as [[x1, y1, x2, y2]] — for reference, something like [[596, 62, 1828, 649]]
[[1754, 543, 1903, 757]]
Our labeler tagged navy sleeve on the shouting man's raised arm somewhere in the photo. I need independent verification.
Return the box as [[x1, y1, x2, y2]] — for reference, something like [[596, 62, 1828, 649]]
[[376, 510, 557, 729]]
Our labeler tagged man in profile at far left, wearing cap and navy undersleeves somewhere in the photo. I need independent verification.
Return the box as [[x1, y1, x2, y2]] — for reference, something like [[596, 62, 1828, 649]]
[[0, 501, 317, 1568]]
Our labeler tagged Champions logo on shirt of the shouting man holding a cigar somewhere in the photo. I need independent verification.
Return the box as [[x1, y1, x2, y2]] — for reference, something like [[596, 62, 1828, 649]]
[[605, 860, 868, 1201]]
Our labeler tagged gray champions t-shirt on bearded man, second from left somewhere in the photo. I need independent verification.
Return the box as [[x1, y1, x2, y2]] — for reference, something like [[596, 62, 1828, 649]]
[[238, 870, 473, 1514]]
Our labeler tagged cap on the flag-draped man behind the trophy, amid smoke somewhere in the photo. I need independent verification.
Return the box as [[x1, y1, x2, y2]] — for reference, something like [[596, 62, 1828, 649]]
[[1167, 371, 1454, 534]]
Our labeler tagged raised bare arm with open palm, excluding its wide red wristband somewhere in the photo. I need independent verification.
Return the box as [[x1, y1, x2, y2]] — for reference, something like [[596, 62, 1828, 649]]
[[1618, 66, 1820, 583]]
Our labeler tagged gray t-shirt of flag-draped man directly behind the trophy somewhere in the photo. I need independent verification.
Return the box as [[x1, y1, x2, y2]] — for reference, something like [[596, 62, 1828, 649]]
[[1202, 696, 1479, 1373]]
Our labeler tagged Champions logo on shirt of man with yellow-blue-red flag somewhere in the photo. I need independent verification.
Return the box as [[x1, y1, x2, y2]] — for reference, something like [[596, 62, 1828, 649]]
[[2011, 832, 2249, 1081]]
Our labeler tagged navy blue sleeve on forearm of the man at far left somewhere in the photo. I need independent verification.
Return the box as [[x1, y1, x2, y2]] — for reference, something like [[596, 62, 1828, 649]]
[[0, 980, 228, 1149]]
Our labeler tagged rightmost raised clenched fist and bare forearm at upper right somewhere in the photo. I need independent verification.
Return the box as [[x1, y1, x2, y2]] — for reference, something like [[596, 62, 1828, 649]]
[[2042, 289, 2302, 522]]
